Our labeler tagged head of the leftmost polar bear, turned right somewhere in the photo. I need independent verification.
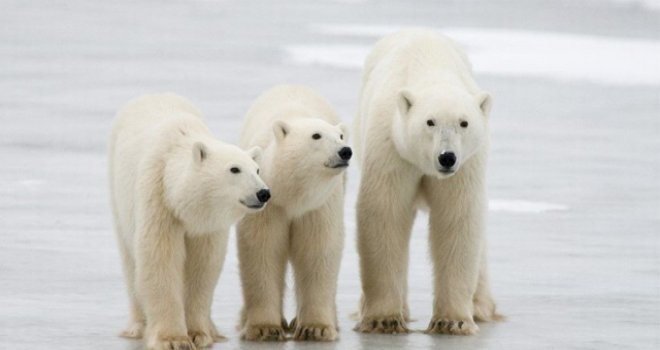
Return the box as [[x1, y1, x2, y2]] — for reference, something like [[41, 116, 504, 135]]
[[165, 140, 270, 232]]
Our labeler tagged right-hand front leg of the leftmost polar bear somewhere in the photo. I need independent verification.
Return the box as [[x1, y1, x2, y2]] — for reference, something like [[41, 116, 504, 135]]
[[185, 232, 228, 348]]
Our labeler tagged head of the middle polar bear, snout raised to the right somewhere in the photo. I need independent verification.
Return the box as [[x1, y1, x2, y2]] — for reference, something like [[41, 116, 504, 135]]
[[273, 118, 353, 176]]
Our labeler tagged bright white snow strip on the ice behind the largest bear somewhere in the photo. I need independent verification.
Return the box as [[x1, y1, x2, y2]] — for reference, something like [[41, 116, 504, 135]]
[[285, 25, 660, 86]]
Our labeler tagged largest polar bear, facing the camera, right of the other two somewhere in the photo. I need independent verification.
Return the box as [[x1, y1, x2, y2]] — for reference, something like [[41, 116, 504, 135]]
[[355, 29, 498, 334]]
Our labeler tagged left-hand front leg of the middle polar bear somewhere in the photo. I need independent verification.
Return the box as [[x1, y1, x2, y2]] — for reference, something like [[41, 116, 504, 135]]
[[236, 206, 289, 341]]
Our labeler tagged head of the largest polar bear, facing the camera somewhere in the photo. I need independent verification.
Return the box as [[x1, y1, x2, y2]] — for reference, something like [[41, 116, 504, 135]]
[[392, 86, 492, 178]]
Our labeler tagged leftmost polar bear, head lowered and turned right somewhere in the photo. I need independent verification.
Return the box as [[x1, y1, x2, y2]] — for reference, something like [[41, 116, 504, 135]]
[[109, 94, 270, 350]]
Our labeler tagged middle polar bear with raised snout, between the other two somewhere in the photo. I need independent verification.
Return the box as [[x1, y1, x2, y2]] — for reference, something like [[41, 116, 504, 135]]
[[237, 85, 352, 341]]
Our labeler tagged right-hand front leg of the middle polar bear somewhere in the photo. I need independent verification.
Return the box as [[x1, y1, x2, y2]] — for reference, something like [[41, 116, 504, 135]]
[[291, 198, 344, 341]]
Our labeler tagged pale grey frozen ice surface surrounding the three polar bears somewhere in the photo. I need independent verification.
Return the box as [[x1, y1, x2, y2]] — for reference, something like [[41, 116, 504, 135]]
[[0, 0, 660, 350]]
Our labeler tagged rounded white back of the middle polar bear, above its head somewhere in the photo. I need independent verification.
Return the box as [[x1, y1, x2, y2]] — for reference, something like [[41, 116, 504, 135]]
[[240, 85, 341, 149]]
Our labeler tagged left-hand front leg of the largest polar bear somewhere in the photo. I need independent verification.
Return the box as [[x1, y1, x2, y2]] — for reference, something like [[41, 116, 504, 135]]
[[355, 173, 419, 334]]
